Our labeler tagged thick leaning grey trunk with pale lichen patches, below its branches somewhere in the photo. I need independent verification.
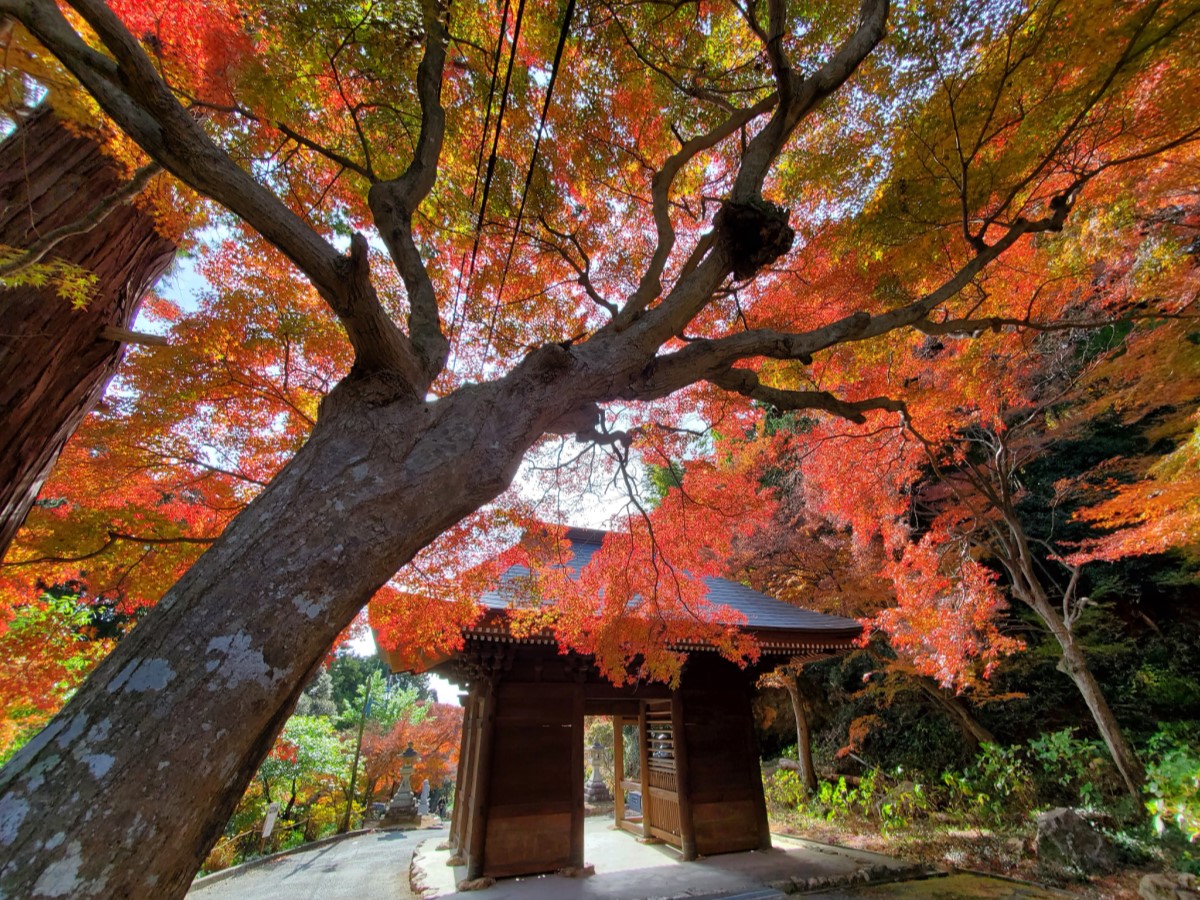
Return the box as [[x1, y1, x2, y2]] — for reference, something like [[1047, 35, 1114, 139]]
[[0, 344, 598, 898]]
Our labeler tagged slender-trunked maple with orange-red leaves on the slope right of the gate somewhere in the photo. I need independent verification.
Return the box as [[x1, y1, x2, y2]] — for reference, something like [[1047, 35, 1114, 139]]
[[739, 181, 1196, 808]]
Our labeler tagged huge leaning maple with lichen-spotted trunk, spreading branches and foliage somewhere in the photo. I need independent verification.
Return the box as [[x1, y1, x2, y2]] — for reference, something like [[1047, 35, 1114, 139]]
[[0, 0, 1198, 895]]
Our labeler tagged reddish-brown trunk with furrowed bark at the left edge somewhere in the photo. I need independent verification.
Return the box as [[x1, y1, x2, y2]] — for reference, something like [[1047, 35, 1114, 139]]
[[0, 110, 175, 559]]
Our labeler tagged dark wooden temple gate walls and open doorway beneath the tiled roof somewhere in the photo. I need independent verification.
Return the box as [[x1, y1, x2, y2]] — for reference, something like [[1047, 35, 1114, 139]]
[[450, 643, 770, 877]]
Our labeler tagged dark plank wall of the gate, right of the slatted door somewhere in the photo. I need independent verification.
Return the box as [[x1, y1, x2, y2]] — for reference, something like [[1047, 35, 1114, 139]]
[[678, 654, 770, 856]]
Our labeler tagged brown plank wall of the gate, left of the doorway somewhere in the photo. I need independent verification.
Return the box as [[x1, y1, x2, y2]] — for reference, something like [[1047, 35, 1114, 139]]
[[482, 680, 583, 877]]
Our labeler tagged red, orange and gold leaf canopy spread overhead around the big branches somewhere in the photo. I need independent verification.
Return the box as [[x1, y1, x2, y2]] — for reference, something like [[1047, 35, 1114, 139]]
[[0, 0, 1195, 724]]
